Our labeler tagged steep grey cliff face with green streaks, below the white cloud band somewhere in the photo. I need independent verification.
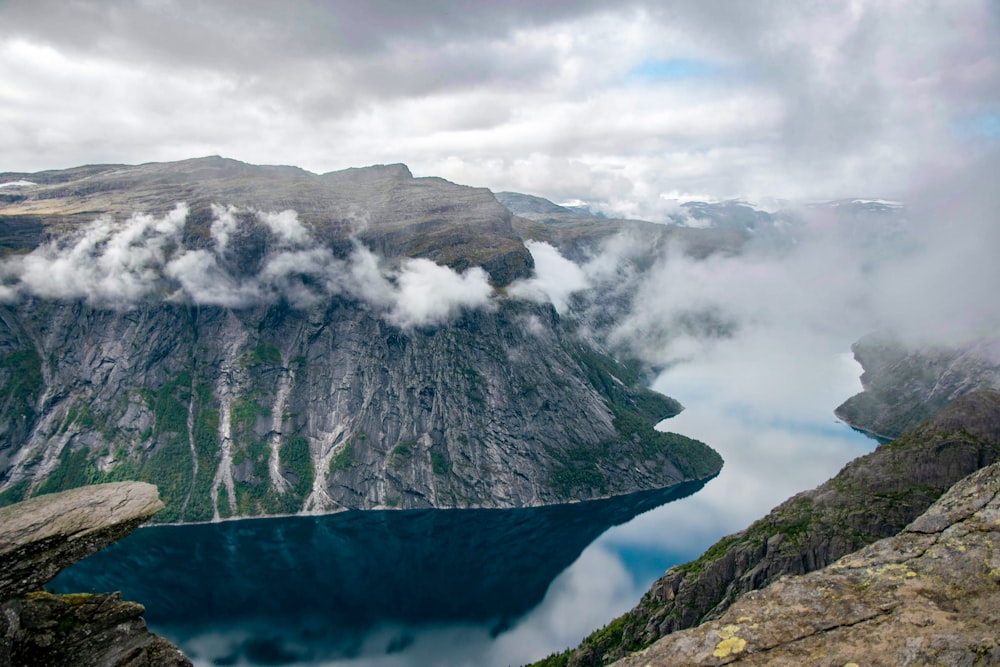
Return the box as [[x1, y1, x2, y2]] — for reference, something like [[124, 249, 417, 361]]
[[0, 298, 721, 521]]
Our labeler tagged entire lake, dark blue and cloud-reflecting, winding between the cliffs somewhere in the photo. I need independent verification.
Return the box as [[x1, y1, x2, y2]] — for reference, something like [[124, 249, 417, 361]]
[[53, 342, 874, 667]]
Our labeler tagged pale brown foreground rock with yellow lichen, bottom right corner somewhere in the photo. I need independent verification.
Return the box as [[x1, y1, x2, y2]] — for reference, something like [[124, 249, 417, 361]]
[[615, 464, 1000, 667]]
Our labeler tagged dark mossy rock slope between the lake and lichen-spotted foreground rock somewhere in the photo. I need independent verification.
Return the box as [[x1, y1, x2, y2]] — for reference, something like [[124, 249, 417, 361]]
[[538, 391, 1000, 665]]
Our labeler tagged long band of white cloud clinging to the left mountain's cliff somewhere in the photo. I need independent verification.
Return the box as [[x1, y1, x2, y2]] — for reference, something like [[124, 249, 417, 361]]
[[0, 204, 493, 329]]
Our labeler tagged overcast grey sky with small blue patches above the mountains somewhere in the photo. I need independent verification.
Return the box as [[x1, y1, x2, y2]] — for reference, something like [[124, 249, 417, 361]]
[[0, 0, 1000, 214]]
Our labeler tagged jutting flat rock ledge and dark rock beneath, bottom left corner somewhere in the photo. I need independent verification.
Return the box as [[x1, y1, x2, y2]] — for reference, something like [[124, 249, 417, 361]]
[[0, 482, 191, 667]]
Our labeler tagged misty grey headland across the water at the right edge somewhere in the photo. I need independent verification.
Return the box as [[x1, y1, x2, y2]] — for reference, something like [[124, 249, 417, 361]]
[[835, 334, 1000, 439]]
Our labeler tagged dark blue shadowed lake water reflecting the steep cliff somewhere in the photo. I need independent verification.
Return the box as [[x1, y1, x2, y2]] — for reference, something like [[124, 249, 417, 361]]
[[52, 483, 703, 665]]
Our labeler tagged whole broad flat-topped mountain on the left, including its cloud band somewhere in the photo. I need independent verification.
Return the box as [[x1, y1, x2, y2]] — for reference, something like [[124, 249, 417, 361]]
[[0, 157, 722, 522]]
